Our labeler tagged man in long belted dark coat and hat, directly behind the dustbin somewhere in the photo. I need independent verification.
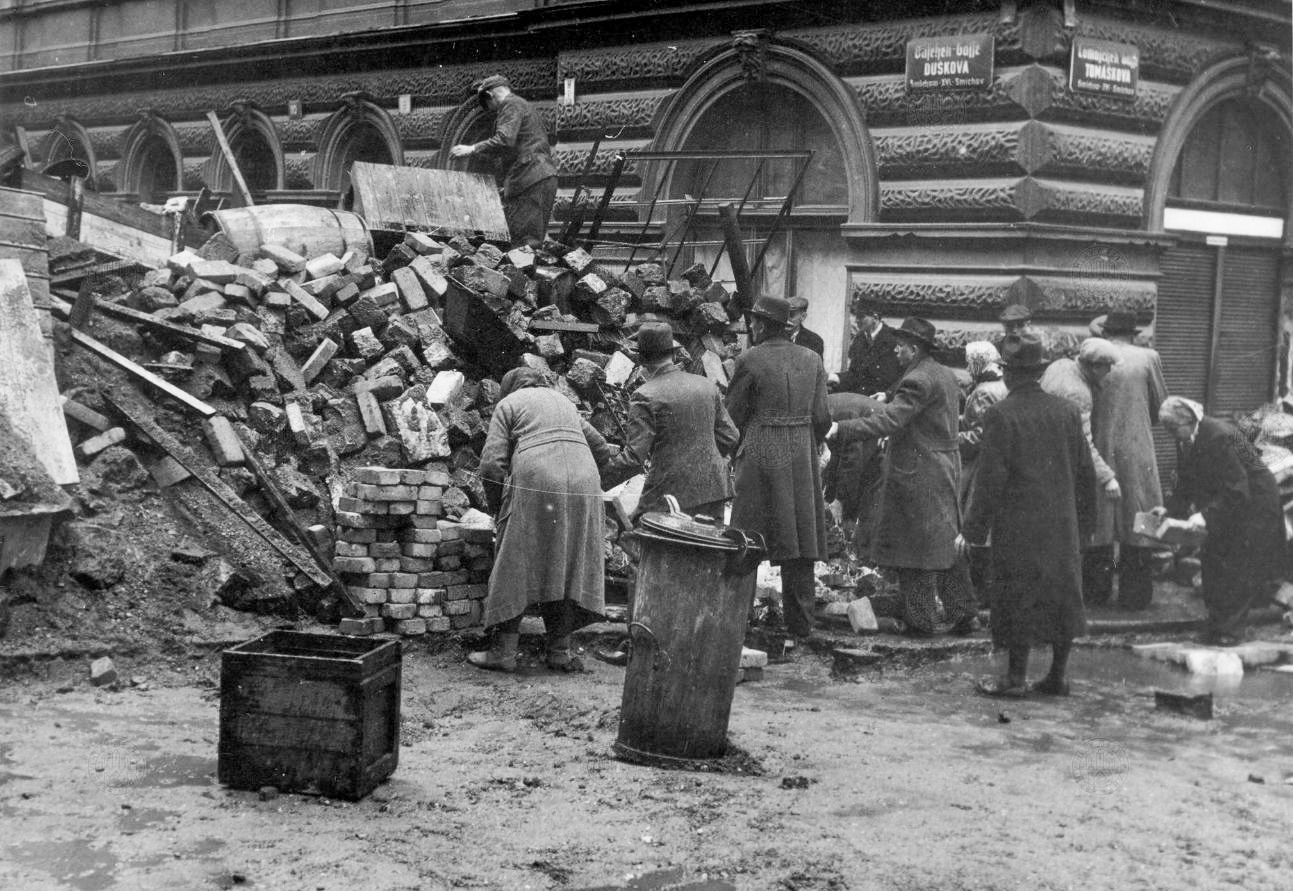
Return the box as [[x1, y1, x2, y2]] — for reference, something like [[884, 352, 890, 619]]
[[727, 297, 830, 636]]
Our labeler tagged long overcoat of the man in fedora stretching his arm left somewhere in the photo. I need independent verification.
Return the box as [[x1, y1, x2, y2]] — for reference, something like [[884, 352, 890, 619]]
[[837, 356, 961, 570]]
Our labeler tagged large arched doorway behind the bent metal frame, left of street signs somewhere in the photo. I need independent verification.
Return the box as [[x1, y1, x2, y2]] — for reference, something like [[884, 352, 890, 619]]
[[643, 39, 878, 370]]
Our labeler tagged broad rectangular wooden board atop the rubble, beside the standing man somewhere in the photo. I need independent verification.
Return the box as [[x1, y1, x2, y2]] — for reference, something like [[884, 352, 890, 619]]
[[350, 160, 511, 242]]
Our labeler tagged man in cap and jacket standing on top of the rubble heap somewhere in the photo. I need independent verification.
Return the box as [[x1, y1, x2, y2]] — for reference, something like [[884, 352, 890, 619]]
[[449, 74, 557, 247]]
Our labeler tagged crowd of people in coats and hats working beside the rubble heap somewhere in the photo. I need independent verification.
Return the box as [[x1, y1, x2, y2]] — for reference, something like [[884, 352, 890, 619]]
[[469, 289, 1284, 697]]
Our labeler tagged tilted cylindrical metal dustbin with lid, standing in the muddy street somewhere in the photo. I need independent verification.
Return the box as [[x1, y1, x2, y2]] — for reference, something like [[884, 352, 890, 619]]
[[614, 498, 764, 764]]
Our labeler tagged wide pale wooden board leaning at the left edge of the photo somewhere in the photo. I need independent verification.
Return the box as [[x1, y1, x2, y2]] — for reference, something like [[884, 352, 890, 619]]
[[0, 260, 80, 485]]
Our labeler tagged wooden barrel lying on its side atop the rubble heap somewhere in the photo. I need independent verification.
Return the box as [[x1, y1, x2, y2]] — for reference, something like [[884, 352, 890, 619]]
[[203, 204, 372, 257]]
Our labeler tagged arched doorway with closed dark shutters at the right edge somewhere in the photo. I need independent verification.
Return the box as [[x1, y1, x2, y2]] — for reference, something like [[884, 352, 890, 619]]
[[1147, 59, 1293, 468]]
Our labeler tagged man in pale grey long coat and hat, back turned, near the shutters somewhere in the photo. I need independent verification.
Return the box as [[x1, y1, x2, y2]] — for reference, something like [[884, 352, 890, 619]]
[[1084, 309, 1168, 610]]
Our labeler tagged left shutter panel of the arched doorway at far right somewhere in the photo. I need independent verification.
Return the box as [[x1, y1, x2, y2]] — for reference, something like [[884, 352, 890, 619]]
[[1153, 242, 1217, 482]]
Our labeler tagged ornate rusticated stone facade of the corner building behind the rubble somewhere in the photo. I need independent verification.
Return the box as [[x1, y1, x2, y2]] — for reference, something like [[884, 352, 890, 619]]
[[0, 0, 1293, 414]]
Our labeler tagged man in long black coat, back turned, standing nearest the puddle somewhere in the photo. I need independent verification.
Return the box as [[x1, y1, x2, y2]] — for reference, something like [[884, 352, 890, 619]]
[[958, 332, 1095, 697]]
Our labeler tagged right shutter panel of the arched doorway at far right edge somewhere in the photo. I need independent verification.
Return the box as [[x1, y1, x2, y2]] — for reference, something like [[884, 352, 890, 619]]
[[1208, 246, 1279, 415]]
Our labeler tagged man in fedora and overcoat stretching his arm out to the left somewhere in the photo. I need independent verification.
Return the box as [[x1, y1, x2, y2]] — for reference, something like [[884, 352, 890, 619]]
[[831, 317, 975, 635]]
